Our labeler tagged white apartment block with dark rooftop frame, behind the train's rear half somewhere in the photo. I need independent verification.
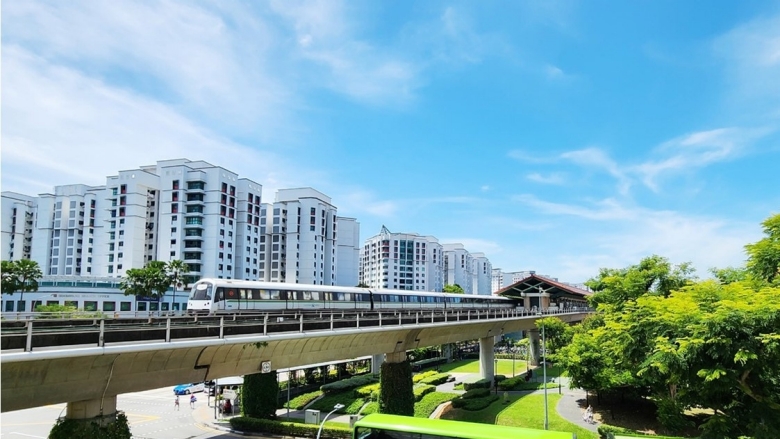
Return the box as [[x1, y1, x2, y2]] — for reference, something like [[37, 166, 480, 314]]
[[360, 226, 444, 291]]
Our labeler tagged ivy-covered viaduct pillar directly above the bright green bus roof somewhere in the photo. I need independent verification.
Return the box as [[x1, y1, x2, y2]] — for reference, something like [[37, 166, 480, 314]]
[[379, 351, 414, 416]]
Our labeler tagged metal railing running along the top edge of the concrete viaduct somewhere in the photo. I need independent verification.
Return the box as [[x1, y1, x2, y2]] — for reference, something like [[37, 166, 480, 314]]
[[0, 308, 592, 352]]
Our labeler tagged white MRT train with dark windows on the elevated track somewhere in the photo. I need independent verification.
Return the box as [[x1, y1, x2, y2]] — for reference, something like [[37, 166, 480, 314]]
[[187, 279, 518, 314]]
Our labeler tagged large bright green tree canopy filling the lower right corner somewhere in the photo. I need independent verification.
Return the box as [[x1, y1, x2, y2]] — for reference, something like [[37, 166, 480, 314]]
[[556, 215, 780, 438]]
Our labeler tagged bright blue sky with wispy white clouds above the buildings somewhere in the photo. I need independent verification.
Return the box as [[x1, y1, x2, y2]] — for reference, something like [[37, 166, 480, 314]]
[[2, 0, 780, 282]]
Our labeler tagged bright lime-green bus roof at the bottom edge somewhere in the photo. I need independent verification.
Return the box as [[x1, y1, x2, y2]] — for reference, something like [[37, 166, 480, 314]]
[[355, 413, 575, 439]]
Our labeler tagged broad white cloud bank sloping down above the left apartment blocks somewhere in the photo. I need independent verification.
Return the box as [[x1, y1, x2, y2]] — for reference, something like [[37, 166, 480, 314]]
[[2, 47, 301, 199]]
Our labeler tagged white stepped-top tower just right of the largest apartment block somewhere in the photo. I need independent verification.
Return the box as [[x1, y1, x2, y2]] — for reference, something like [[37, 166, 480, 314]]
[[260, 188, 337, 285]]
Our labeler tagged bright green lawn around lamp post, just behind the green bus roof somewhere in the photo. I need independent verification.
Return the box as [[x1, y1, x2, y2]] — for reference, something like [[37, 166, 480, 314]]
[[442, 394, 598, 439]]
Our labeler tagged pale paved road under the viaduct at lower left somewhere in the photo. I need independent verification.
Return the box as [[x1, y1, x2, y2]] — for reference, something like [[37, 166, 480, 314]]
[[0, 387, 239, 439]]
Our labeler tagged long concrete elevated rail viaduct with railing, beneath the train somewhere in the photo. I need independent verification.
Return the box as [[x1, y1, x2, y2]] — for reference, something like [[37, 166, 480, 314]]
[[0, 308, 591, 417]]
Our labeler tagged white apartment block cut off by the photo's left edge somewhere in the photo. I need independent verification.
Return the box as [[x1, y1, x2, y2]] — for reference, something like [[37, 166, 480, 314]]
[[0, 192, 37, 261]]
